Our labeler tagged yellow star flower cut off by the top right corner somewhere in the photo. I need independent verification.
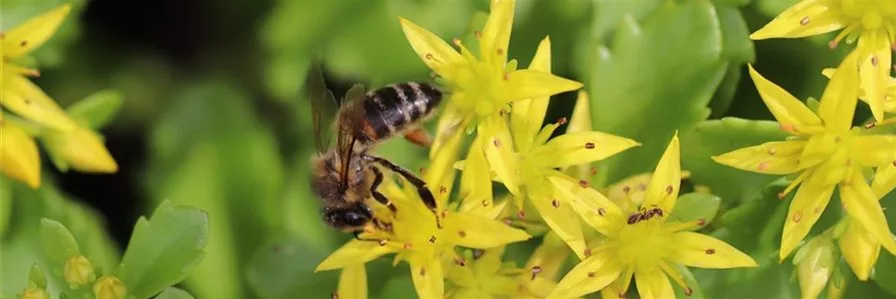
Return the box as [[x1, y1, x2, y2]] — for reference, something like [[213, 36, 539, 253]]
[[750, 0, 896, 122]]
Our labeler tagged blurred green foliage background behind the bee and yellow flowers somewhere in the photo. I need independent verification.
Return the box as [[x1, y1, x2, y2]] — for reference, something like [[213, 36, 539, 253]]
[[0, 0, 896, 299]]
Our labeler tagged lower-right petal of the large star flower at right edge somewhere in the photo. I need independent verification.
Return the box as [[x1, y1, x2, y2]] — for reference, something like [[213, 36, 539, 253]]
[[840, 168, 896, 254]]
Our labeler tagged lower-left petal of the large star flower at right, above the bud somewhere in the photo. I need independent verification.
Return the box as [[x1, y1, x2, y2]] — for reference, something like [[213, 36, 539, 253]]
[[779, 182, 836, 260]]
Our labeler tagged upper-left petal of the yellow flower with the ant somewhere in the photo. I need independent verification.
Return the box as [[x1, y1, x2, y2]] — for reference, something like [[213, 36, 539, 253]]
[[548, 176, 625, 236]]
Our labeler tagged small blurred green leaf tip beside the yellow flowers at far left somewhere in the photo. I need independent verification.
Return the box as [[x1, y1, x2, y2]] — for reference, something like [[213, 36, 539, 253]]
[[65, 89, 124, 130]]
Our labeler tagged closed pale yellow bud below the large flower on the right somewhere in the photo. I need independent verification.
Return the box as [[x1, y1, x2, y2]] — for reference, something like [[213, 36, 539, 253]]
[[794, 236, 837, 298]]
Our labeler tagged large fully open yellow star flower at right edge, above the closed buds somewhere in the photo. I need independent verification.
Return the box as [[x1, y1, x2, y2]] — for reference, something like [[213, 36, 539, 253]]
[[713, 52, 896, 260]]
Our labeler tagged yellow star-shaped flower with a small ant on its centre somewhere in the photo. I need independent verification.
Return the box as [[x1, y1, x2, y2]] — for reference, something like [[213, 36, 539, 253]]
[[548, 134, 757, 298]]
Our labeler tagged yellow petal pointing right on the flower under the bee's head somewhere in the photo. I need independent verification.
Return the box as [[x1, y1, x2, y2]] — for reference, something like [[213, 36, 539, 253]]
[[443, 213, 531, 249]]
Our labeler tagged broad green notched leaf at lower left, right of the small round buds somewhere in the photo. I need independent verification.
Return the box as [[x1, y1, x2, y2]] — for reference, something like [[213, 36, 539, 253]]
[[116, 201, 208, 298]]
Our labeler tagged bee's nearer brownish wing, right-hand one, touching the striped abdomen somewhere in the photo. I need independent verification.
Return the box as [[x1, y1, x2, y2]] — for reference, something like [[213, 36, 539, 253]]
[[336, 84, 366, 182]]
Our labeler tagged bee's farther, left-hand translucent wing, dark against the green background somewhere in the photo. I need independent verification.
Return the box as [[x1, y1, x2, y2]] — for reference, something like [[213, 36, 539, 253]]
[[305, 67, 339, 153]]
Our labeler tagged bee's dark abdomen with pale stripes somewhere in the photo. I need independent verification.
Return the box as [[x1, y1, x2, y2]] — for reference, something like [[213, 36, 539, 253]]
[[356, 82, 442, 141]]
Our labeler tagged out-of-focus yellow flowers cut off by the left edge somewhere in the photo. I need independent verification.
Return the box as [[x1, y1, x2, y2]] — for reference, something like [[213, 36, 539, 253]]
[[0, 4, 118, 188]]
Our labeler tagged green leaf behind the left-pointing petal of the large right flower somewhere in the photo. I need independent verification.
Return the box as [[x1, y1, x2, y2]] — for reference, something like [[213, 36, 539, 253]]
[[681, 118, 787, 201]]
